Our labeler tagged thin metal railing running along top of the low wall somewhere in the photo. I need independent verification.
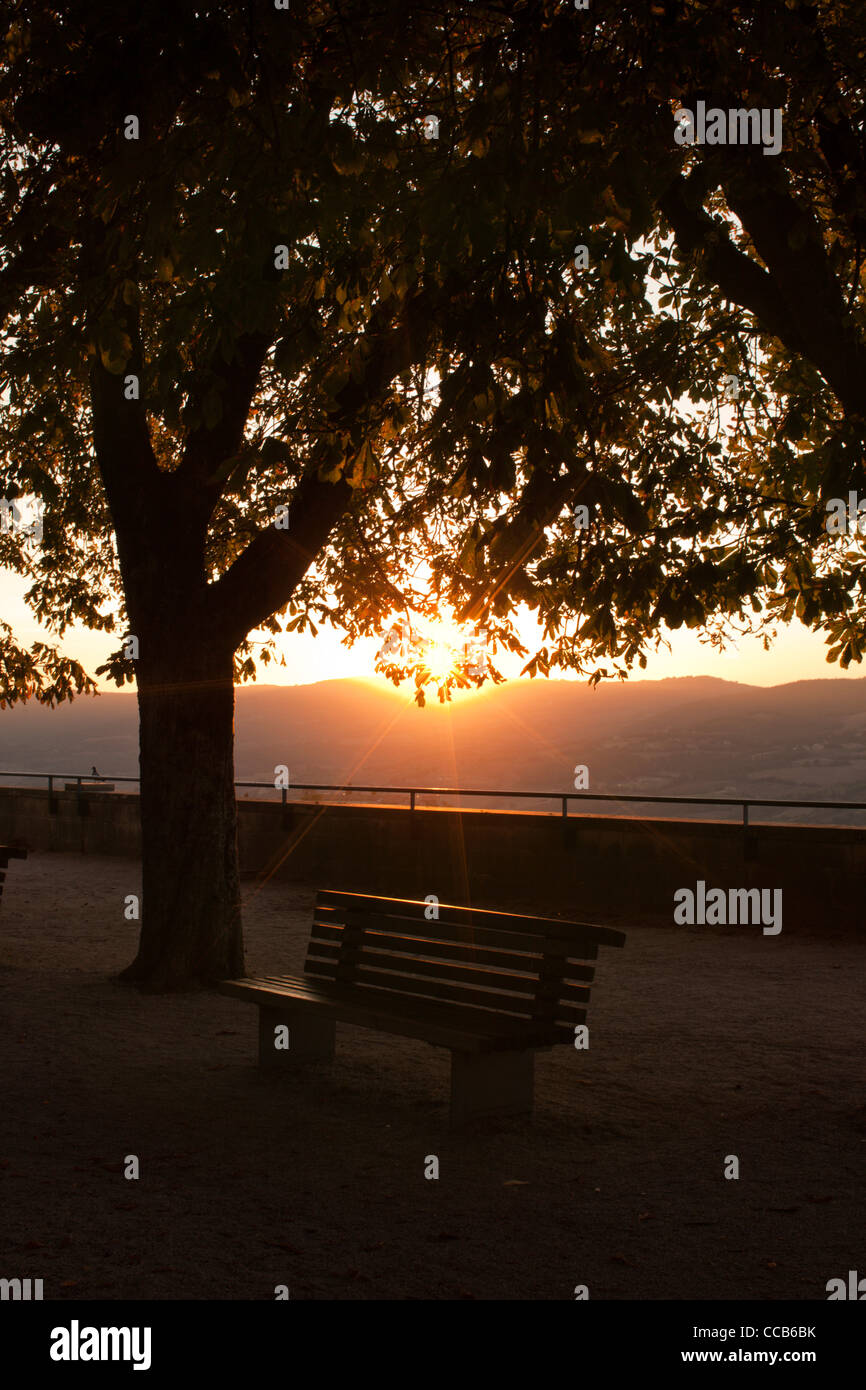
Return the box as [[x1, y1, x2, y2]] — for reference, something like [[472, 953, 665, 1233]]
[[0, 771, 866, 830]]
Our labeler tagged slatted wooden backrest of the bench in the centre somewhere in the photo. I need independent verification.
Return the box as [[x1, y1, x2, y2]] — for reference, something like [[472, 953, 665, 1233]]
[[304, 890, 626, 1041]]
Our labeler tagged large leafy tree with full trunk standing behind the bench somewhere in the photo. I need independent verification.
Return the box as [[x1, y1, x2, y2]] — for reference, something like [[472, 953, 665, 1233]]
[[0, 0, 856, 988]]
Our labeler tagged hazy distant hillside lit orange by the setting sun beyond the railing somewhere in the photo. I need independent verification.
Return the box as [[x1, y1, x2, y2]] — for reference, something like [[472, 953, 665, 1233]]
[[0, 677, 866, 820]]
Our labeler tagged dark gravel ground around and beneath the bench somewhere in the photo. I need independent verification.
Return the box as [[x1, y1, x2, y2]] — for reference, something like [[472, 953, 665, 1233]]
[[0, 853, 866, 1300]]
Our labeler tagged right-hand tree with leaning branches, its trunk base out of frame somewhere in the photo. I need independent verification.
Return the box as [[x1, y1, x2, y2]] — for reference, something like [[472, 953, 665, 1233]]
[[422, 0, 866, 681]]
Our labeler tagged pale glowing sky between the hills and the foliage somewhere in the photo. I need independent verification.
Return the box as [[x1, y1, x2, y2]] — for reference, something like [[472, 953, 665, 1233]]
[[0, 570, 865, 689]]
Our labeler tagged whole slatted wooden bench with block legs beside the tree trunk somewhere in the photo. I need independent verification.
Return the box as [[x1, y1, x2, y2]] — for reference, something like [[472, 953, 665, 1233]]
[[220, 890, 626, 1125]]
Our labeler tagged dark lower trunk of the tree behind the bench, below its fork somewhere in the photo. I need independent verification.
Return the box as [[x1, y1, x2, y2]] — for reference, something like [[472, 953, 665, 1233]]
[[121, 639, 243, 990]]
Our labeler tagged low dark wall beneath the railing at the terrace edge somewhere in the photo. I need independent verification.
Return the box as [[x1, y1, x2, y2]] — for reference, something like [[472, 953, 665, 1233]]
[[0, 788, 866, 931]]
